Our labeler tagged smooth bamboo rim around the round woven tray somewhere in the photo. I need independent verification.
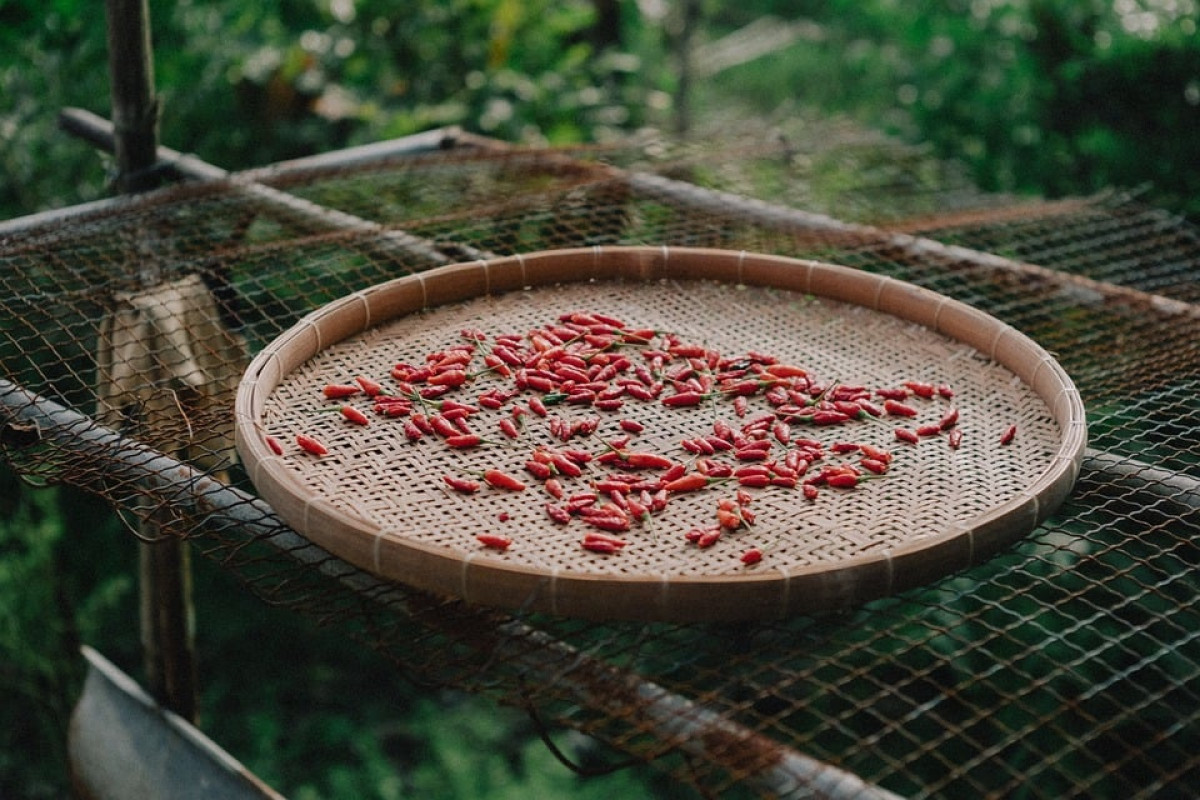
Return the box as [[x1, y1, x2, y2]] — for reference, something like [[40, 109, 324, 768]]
[[235, 246, 1087, 622]]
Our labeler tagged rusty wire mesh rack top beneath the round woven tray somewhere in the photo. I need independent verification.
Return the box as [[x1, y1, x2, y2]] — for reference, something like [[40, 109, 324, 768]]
[[0, 120, 1200, 798]]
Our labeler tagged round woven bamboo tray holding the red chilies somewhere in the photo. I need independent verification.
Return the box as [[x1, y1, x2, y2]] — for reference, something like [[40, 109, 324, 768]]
[[236, 247, 1086, 621]]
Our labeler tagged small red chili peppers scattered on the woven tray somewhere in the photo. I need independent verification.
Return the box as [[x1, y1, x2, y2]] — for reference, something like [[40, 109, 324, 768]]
[[268, 311, 1016, 566]]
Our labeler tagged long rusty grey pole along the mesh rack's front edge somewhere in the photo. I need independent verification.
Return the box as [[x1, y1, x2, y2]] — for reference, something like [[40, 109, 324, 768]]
[[0, 379, 896, 800]]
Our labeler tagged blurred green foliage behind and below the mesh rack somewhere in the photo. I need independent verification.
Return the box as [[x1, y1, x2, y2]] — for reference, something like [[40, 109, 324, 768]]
[[0, 0, 1200, 798]]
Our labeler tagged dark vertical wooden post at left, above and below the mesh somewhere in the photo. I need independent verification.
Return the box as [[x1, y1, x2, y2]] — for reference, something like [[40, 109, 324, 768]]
[[106, 0, 197, 722]]
